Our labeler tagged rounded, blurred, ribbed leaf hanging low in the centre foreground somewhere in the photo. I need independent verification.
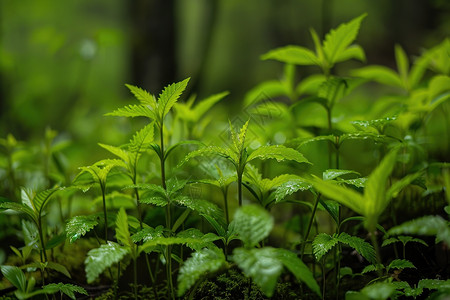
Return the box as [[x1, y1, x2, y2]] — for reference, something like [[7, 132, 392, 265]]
[[233, 205, 274, 248]]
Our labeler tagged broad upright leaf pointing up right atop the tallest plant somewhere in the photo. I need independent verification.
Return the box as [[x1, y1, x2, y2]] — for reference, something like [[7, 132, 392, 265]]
[[323, 14, 367, 66]]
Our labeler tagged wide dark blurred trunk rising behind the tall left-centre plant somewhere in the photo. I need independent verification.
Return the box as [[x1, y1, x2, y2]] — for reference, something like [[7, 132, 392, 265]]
[[129, 0, 176, 94]]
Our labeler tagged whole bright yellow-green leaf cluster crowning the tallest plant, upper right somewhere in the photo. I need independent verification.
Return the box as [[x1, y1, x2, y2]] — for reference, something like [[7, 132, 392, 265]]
[[261, 14, 366, 75]]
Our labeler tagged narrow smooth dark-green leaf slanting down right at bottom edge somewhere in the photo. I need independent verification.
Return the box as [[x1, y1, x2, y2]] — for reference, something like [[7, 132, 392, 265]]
[[275, 248, 321, 297]]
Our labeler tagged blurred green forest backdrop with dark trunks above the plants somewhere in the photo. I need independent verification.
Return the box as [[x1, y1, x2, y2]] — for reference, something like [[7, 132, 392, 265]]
[[0, 0, 450, 165]]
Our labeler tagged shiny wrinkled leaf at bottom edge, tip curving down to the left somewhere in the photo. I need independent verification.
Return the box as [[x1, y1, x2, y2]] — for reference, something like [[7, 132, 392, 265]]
[[177, 248, 227, 297]]
